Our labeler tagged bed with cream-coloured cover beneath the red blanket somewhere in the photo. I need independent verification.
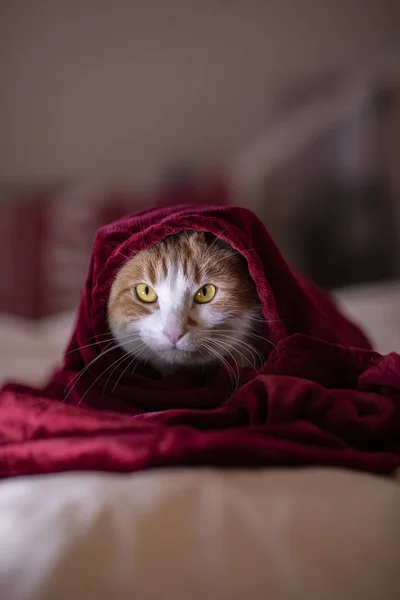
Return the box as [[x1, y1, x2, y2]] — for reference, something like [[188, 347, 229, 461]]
[[0, 282, 400, 600]]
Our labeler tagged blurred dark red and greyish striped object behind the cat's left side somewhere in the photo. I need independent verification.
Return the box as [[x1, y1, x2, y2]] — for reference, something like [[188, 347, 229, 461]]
[[0, 177, 229, 319]]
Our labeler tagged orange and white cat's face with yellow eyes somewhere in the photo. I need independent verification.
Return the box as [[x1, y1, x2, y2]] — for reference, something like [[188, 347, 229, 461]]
[[108, 231, 258, 373]]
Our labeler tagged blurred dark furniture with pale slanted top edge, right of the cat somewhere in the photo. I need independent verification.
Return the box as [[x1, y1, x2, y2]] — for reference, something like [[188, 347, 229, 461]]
[[228, 45, 400, 290]]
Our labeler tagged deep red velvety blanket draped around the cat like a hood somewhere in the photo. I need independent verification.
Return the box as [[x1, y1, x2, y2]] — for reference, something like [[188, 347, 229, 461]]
[[0, 206, 400, 477]]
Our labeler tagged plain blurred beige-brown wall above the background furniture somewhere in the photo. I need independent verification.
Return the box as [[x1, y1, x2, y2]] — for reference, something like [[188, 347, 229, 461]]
[[0, 0, 400, 182]]
